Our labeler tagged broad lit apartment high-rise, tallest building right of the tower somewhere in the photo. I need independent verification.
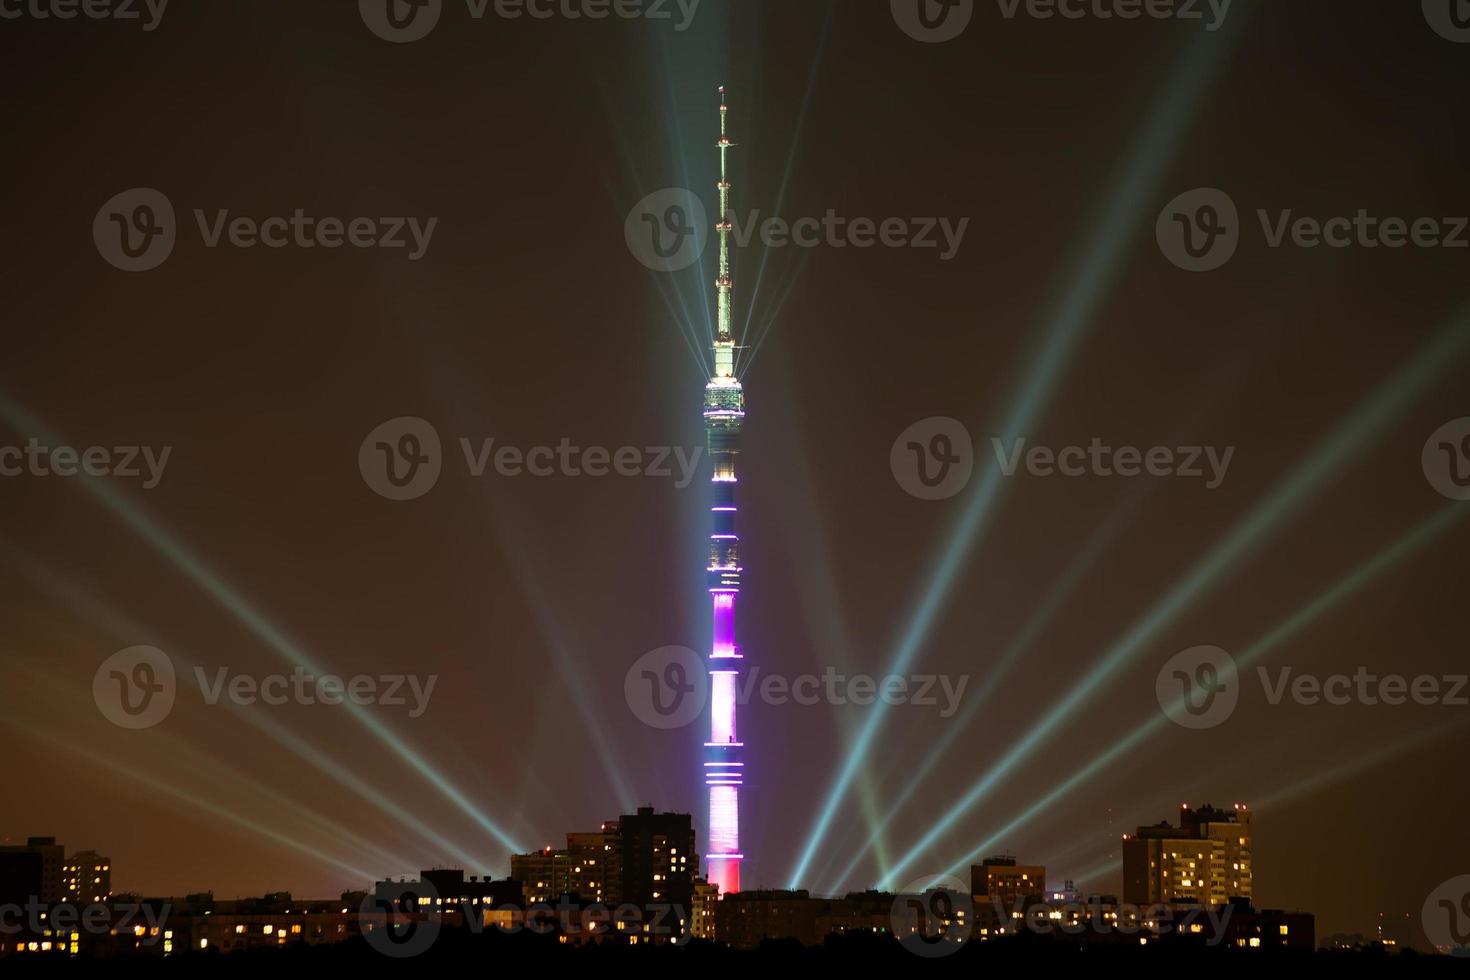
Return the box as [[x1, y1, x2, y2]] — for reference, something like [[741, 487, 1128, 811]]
[[1123, 804, 1254, 905]]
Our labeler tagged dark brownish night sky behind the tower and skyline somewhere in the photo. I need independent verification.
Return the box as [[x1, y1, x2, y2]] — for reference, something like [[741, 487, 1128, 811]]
[[0, 0, 1470, 936]]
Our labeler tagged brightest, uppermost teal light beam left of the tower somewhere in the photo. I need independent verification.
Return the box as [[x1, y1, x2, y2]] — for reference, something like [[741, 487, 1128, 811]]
[[0, 392, 522, 854]]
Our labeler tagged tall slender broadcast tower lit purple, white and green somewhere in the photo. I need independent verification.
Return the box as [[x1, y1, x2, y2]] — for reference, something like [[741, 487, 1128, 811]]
[[704, 85, 745, 895]]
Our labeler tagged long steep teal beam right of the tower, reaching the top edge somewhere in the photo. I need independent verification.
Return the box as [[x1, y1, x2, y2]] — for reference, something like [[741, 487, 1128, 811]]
[[789, 18, 1247, 887]]
